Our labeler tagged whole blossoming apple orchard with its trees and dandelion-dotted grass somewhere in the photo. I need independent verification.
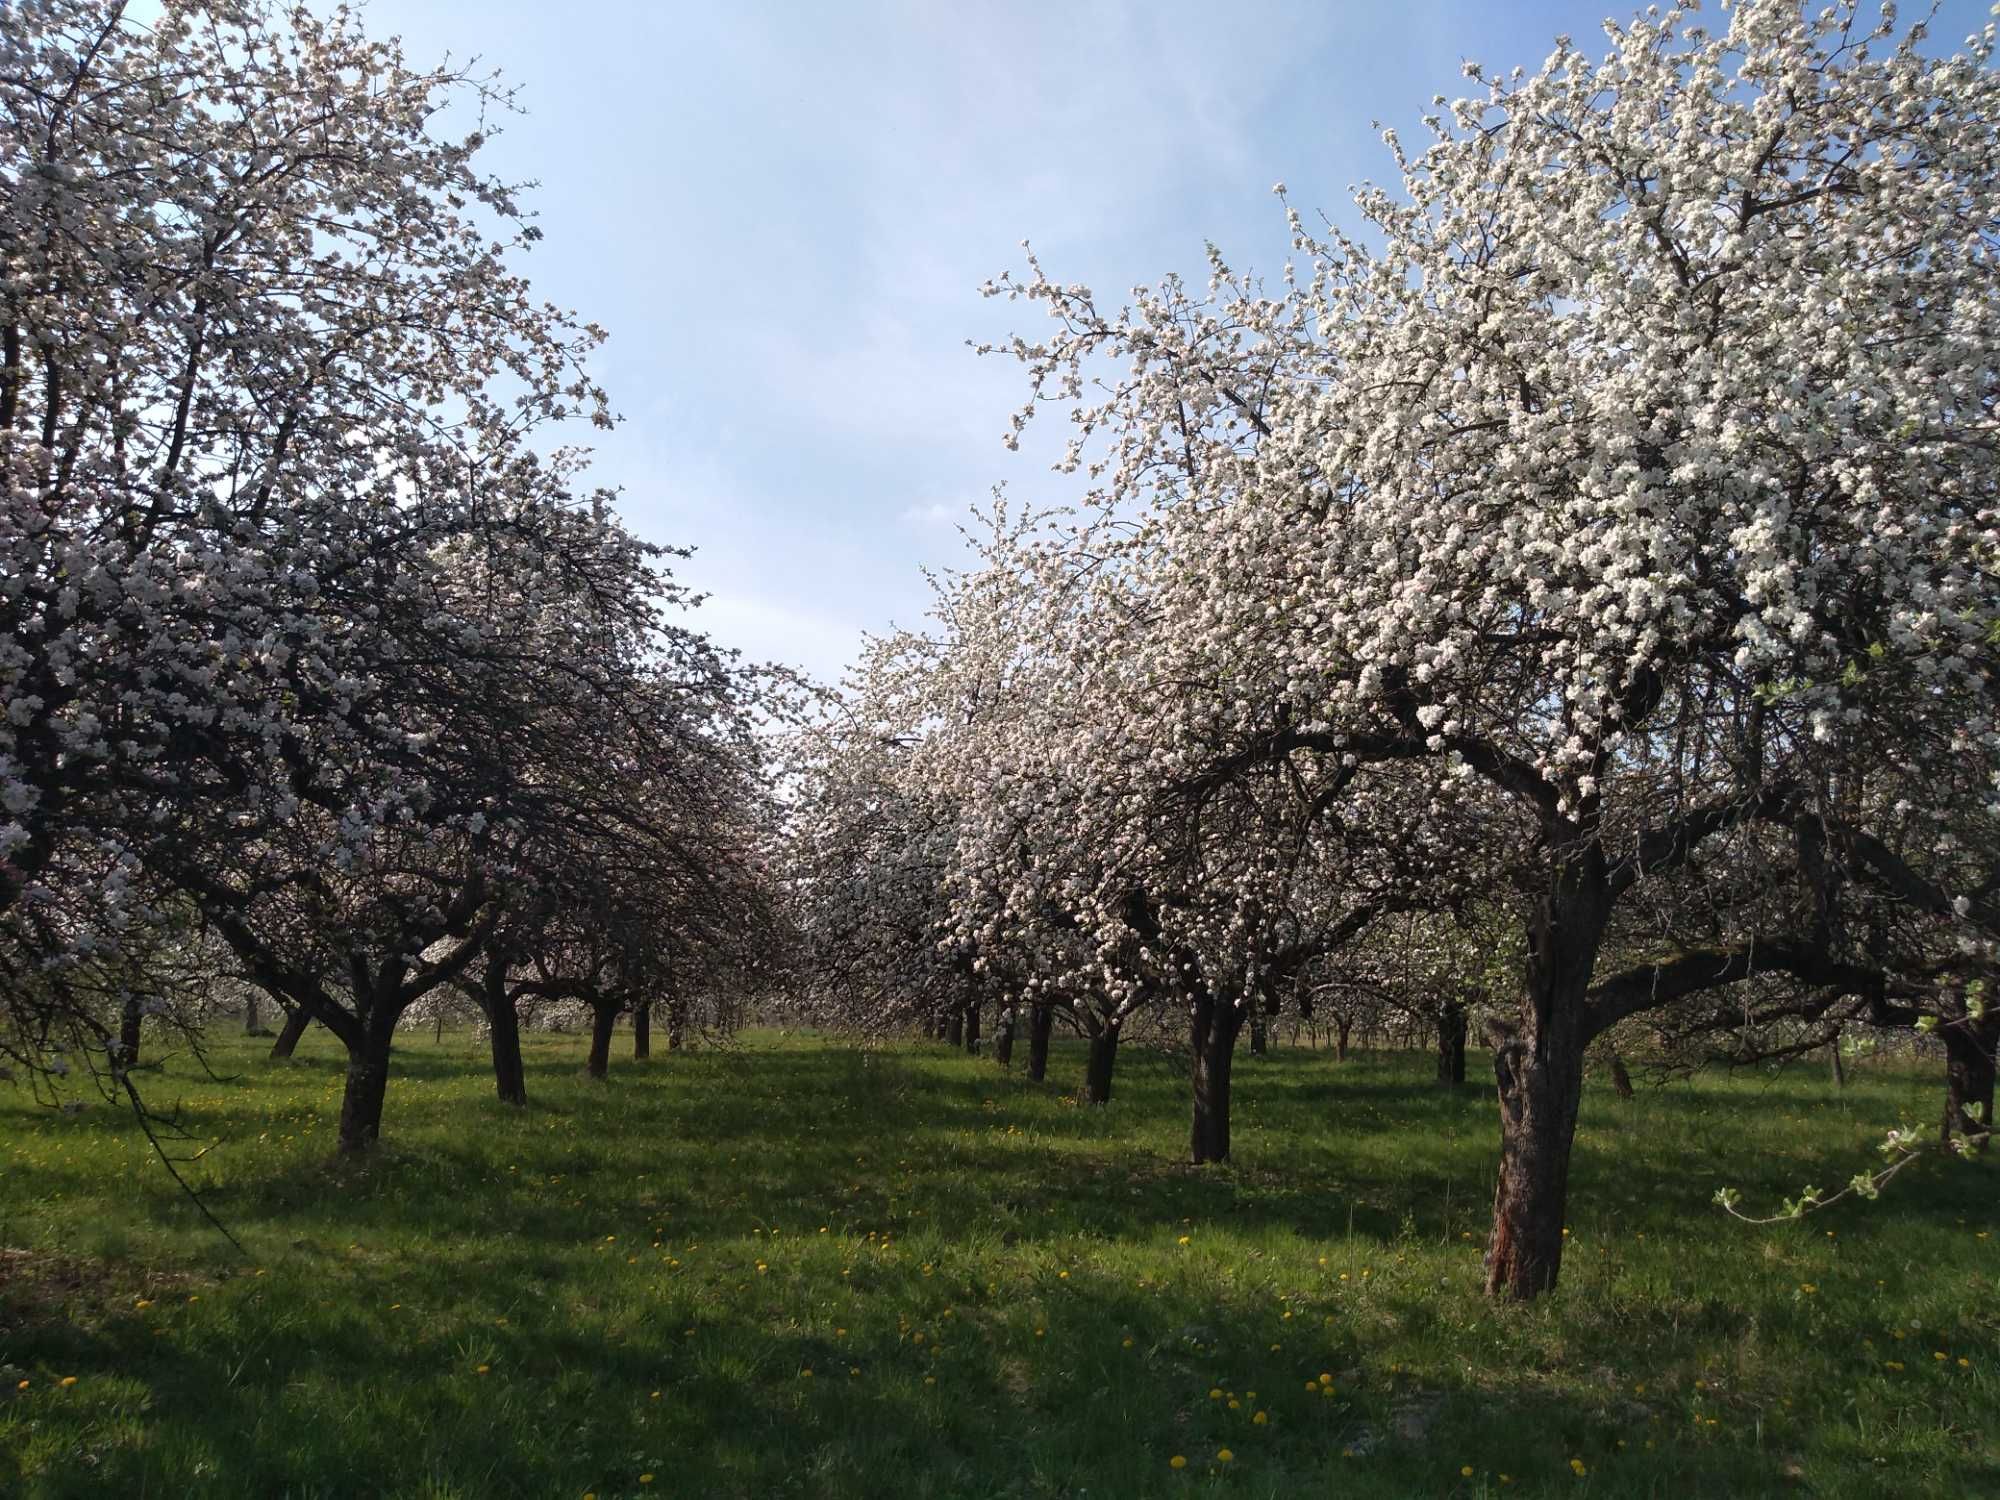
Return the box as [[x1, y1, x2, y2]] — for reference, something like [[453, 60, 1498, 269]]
[[0, 0, 2000, 1496]]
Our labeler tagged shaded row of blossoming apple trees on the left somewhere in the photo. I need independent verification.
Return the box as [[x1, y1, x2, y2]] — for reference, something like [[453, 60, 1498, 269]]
[[0, 0, 780, 1152]]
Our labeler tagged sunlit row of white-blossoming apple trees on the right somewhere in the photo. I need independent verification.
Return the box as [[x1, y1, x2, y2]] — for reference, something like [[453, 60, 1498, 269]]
[[792, 0, 2000, 1298]]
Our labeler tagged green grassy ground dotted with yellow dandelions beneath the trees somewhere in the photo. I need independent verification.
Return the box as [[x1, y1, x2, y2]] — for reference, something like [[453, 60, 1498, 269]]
[[0, 1036, 2000, 1500]]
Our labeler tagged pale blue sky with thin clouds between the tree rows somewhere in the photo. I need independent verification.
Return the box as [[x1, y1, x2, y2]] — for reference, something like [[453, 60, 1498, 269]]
[[368, 0, 1984, 678]]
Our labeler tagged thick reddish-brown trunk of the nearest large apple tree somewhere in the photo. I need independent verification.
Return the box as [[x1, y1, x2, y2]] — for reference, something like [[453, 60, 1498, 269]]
[[1486, 868, 1610, 1300]]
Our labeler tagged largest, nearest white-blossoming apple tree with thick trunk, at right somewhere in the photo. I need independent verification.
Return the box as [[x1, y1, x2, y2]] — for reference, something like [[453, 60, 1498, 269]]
[[976, 0, 2000, 1296]]
